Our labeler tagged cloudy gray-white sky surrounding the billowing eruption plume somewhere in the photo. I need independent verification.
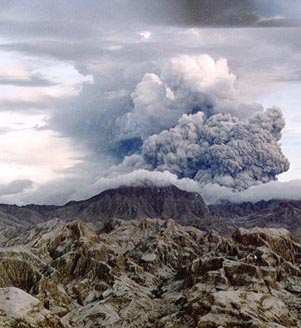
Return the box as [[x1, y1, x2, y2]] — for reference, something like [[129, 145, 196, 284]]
[[0, 0, 301, 203]]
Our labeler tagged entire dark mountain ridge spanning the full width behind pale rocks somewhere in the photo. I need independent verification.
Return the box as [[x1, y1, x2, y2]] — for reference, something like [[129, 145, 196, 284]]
[[0, 185, 301, 241]]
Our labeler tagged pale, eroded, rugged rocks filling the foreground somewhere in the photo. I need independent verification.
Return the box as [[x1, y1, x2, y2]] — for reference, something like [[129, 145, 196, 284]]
[[0, 219, 301, 328]]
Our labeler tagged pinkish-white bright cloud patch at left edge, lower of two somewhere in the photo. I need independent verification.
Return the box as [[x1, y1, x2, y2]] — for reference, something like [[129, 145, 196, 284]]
[[0, 129, 84, 184]]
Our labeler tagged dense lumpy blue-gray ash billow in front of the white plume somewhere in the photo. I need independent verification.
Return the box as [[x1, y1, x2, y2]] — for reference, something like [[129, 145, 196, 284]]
[[142, 107, 289, 190]]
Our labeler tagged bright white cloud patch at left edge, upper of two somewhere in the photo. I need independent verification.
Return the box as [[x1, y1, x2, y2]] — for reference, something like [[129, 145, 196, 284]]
[[0, 50, 94, 110]]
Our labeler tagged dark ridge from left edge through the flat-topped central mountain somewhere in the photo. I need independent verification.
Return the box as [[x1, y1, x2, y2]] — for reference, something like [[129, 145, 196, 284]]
[[0, 186, 210, 242]]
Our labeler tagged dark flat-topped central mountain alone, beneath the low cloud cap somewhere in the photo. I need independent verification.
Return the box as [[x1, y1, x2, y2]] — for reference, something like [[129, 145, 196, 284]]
[[52, 186, 209, 225]]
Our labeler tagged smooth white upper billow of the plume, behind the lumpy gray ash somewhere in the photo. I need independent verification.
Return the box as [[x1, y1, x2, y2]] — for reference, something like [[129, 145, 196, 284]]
[[118, 55, 237, 139]]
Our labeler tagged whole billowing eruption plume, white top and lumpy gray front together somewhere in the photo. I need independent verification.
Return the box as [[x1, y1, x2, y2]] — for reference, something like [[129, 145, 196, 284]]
[[112, 55, 289, 190]]
